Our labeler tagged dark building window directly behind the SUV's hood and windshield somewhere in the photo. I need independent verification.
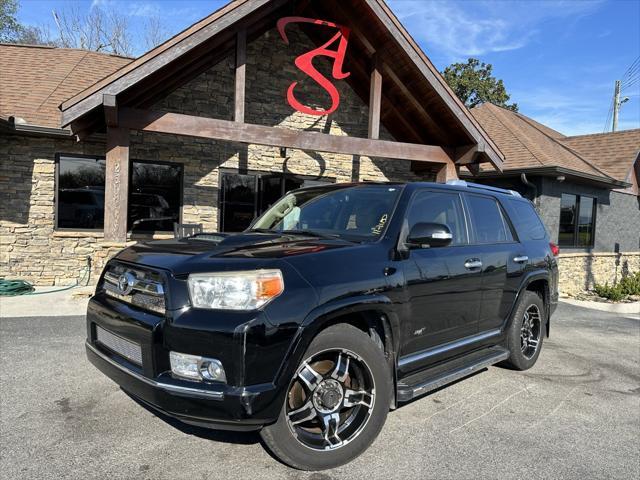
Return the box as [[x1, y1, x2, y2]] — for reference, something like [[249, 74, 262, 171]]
[[219, 172, 330, 232]]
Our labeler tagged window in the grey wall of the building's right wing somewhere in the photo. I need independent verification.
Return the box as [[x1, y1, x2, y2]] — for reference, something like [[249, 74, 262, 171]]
[[558, 193, 596, 247]]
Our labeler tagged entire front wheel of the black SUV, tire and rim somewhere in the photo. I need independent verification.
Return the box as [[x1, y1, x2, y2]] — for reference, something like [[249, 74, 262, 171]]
[[261, 324, 391, 470]]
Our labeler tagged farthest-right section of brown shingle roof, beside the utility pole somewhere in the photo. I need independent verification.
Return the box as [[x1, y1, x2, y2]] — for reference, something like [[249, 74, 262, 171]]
[[562, 128, 640, 182]]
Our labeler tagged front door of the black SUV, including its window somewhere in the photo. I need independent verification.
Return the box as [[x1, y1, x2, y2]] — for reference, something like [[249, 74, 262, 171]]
[[401, 190, 481, 368]]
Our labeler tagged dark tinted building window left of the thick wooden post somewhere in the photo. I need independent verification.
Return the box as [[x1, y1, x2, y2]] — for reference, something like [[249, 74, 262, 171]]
[[57, 157, 105, 229]]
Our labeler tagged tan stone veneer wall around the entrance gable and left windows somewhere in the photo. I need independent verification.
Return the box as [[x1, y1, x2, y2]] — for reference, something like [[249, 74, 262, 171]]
[[0, 28, 429, 285]]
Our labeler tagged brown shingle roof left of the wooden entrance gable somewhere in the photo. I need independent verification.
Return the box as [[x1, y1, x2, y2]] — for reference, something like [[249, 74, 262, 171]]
[[0, 44, 131, 128]]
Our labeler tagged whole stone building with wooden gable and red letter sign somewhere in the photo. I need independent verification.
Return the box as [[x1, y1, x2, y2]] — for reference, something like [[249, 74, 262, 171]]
[[0, 0, 640, 291]]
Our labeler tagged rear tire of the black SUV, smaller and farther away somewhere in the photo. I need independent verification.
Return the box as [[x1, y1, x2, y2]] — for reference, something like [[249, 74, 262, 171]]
[[503, 290, 546, 370]]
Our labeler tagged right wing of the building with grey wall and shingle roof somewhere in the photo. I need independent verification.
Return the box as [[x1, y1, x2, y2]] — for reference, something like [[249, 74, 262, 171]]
[[462, 104, 640, 294]]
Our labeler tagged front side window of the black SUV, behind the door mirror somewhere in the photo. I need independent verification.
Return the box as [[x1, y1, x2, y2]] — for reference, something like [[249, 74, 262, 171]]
[[407, 191, 467, 245]]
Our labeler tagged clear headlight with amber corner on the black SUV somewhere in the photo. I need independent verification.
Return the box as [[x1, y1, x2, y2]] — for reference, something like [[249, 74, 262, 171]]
[[188, 270, 284, 310]]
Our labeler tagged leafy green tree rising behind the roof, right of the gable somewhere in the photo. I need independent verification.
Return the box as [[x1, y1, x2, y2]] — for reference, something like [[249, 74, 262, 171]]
[[442, 58, 518, 112]]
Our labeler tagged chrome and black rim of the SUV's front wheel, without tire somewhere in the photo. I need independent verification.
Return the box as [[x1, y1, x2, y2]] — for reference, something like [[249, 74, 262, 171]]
[[285, 349, 375, 450]]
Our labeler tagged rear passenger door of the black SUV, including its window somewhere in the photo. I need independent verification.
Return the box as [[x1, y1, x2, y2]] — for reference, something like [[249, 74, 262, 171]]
[[465, 194, 528, 334]]
